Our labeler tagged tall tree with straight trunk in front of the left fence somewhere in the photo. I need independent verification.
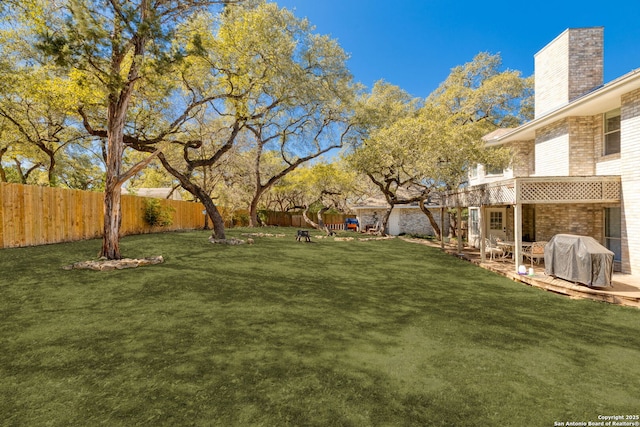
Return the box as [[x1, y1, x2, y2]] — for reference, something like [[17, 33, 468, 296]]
[[10, 0, 241, 259]]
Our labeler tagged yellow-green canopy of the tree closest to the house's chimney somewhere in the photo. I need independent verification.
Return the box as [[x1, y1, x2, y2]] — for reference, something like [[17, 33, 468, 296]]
[[348, 54, 532, 201]]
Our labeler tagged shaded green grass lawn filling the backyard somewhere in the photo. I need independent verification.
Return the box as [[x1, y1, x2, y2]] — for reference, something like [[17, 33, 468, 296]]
[[0, 229, 640, 426]]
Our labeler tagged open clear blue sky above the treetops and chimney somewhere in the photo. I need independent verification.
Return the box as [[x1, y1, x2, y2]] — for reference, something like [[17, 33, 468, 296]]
[[276, 0, 640, 97]]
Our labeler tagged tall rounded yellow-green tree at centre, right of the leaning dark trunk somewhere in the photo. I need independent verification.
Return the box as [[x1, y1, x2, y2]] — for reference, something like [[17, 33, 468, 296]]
[[215, 2, 355, 225]]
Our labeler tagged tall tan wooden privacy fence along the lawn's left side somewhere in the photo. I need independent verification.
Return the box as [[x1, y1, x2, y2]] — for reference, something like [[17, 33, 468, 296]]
[[0, 183, 204, 248]]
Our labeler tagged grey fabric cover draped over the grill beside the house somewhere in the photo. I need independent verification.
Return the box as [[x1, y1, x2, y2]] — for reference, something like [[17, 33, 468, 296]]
[[544, 234, 614, 287]]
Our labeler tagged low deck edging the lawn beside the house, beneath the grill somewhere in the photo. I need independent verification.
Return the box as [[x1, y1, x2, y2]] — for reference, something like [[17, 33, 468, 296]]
[[403, 238, 640, 308]]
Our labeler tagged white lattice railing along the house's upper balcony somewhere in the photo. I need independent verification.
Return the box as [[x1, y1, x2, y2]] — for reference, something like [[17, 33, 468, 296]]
[[444, 176, 622, 207]]
